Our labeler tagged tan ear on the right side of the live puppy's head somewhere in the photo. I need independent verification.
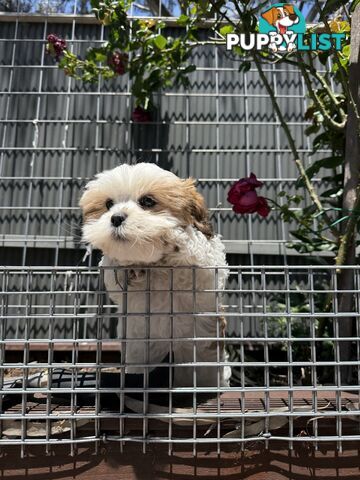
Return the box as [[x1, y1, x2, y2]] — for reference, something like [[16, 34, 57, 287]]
[[183, 178, 214, 238]]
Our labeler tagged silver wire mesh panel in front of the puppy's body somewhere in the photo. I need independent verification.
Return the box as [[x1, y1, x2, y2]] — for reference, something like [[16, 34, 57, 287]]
[[0, 266, 360, 454]]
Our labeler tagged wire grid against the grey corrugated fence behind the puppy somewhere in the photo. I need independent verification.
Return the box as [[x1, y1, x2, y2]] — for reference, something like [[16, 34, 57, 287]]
[[0, 16, 334, 265]]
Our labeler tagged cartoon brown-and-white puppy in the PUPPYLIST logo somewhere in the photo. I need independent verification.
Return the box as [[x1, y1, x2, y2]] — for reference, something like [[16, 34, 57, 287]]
[[261, 5, 299, 52]]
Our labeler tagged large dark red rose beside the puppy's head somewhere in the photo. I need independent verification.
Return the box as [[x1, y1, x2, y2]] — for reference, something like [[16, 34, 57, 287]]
[[228, 173, 270, 217]]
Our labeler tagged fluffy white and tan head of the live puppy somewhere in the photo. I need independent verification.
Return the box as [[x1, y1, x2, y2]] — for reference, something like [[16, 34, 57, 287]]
[[80, 163, 212, 264]]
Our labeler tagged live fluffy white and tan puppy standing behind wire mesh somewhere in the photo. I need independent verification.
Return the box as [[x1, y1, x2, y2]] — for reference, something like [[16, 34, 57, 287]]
[[80, 163, 231, 387]]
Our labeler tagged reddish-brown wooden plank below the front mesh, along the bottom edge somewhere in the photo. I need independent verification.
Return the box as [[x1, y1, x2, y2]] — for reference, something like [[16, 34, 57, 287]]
[[0, 443, 360, 480]]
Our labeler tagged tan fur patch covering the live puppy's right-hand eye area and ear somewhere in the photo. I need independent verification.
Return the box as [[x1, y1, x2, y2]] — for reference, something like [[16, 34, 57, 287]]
[[146, 178, 214, 238]]
